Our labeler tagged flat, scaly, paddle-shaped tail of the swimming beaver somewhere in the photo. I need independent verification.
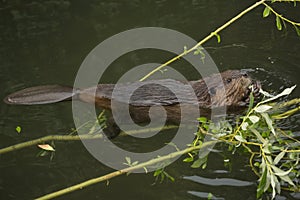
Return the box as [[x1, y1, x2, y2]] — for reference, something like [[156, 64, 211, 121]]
[[4, 85, 78, 105]]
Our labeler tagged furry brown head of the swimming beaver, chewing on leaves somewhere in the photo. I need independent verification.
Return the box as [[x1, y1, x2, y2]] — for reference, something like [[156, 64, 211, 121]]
[[193, 70, 260, 108]]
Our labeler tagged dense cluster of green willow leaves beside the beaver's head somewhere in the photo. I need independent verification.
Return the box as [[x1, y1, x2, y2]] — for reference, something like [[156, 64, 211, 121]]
[[184, 86, 300, 199]]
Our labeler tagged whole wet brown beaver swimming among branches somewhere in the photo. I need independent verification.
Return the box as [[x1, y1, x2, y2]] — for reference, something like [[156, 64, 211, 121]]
[[4, 70, 260, 138]]
